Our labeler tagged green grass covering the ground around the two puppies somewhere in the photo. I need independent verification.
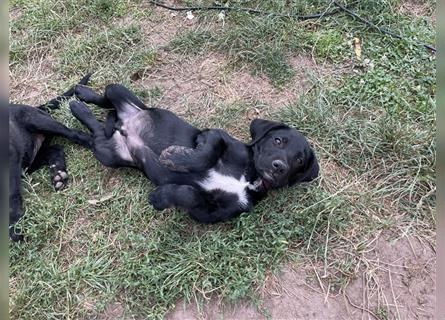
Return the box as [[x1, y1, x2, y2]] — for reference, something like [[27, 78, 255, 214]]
[[9, 0, 436, 319]]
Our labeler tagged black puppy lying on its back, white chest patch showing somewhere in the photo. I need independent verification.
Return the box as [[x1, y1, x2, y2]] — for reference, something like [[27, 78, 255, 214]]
[[70, 84, 319, 223]]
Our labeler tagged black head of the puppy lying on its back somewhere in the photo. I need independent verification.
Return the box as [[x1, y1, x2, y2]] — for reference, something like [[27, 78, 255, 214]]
[[249, 119, 319, 189]]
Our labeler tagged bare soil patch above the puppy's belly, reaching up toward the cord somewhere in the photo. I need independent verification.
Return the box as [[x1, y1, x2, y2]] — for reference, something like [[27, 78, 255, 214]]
[[132, 8, 336, 122]]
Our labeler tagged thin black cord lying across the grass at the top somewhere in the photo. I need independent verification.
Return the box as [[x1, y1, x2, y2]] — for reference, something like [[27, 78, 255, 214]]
[[148, 0, 437, 52]]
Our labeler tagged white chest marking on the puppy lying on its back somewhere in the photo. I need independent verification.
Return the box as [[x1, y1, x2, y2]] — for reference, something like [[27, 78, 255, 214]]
[[199, 169, 250, 206]]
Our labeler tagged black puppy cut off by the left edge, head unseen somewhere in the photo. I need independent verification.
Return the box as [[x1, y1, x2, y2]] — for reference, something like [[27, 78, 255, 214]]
[[9, 75, 92, 241]]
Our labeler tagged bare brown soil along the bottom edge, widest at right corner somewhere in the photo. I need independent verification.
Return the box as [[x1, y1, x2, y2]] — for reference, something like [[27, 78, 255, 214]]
[[166, 237, 436, 320]]
